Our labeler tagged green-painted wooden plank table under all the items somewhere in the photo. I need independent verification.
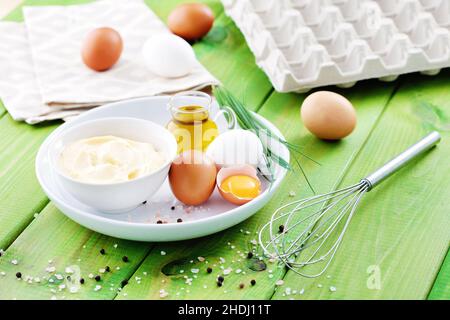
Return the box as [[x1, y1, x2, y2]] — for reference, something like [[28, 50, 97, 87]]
[[0, 0, 450, 299]]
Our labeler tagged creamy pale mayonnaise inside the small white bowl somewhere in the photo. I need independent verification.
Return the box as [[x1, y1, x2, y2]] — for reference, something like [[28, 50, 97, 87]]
[[59, 136, 166, 184]]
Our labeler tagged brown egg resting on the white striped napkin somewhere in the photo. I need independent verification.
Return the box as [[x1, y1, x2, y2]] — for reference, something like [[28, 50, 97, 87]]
[[81, 27, 123, 71]]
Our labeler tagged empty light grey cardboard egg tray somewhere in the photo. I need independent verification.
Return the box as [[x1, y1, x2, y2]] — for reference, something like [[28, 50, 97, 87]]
[[222, 0, 450, 92]]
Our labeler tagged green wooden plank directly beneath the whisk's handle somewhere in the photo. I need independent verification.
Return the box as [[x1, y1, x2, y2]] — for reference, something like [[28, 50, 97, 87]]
[[275, 70, 450, 299]]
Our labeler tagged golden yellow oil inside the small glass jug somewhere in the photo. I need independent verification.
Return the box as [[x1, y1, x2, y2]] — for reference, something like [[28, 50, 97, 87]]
[[167, 105, 219, 153]]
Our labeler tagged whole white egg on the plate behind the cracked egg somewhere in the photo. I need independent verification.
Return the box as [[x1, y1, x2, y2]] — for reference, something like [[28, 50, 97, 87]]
[[206, 129, 264, 168]]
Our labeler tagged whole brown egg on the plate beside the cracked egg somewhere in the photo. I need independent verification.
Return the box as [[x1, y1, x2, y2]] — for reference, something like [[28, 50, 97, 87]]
[[169, 150, 217, 206]]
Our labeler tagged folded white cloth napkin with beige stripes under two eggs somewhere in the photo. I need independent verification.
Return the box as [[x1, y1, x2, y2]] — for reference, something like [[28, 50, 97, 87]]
[[0, 0, 219, 123]]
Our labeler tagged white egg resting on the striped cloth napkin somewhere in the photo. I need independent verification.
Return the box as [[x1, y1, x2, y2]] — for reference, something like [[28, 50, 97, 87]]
[[142, 33, 197, 78]]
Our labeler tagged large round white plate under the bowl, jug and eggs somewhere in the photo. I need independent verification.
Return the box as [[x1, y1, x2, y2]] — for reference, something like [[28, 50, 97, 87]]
[[36, 97, 289, 242]]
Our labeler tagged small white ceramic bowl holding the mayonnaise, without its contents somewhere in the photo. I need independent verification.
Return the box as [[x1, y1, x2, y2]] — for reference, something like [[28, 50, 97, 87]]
[[48, 117, 177, 213]]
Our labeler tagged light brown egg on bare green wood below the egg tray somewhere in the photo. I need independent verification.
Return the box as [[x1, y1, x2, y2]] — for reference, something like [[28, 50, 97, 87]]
[[301, 91, 357, 140]]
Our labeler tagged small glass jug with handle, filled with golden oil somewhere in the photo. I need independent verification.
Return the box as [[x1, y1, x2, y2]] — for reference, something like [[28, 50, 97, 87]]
[[167, 91, 236, 153]]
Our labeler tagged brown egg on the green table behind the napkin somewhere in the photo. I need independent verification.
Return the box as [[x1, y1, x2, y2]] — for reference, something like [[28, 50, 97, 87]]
[[167, 3, 214, 41]]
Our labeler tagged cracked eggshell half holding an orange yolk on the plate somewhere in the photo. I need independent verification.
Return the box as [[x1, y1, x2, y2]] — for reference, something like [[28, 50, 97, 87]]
[[217, 165, 261, 206]]
